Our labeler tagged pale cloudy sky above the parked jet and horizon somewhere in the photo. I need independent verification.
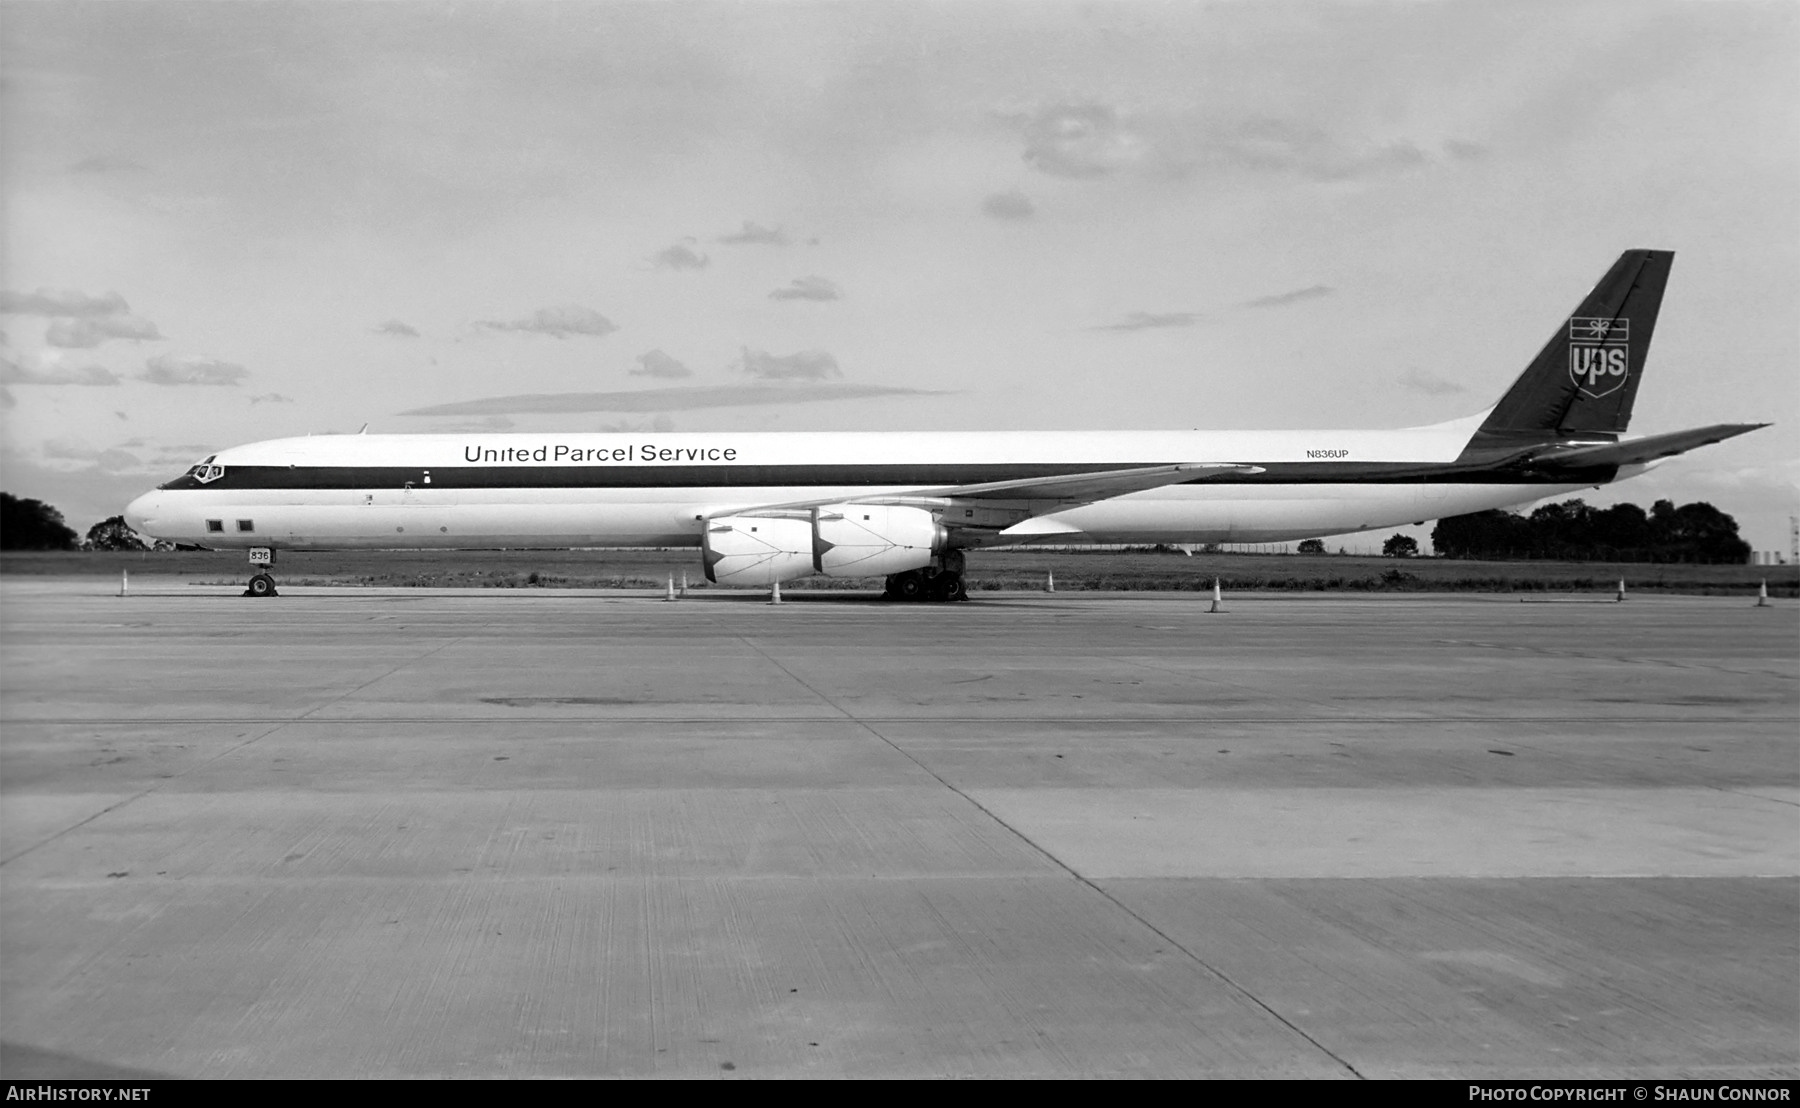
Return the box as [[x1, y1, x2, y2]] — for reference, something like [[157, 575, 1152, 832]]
[[0, 0, 1800, 549]]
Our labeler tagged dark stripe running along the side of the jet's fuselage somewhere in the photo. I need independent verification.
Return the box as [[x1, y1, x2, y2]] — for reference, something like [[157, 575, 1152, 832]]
[[162, 460, 1616, 489]]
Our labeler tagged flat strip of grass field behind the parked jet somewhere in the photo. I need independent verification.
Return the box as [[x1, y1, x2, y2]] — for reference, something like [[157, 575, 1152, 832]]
[[0, 550, 1800, 597]]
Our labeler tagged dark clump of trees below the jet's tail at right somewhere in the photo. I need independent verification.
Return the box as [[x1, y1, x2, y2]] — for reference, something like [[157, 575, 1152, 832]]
[[1431, 500, 1750, 563]]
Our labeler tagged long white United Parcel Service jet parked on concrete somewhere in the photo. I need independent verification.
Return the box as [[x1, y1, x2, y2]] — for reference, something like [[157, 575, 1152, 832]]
[[126, 250, 1766, 599]]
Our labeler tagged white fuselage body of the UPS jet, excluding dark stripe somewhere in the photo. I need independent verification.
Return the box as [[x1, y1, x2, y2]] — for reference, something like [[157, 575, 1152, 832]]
[[126, 428, 1624, 550]]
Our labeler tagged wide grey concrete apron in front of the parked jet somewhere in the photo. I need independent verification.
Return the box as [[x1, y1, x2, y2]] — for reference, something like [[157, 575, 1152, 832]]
[[0, 579, 1800, 1077]]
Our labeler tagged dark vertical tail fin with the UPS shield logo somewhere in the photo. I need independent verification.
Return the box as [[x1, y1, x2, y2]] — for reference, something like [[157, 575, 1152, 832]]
[[1476, 250, 1676, 439]]
